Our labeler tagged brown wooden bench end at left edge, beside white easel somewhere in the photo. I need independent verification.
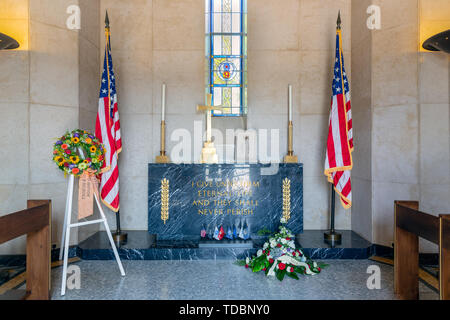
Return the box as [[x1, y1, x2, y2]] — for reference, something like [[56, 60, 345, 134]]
[[0, 200, 52, 300]]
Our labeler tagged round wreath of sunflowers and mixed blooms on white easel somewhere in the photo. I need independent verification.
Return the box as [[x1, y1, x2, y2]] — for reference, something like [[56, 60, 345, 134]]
[[53, 129, 105, 177]]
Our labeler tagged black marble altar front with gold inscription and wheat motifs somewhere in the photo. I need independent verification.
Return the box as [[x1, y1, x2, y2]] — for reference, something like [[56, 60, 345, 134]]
[[148, 164, 303, 243]]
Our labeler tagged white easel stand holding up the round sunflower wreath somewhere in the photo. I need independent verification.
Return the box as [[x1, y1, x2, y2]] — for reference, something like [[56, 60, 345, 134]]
[[59, 175, 125, 296]]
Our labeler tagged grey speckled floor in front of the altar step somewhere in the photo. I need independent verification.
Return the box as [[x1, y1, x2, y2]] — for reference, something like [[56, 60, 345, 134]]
[[52, 260, 438, 300]]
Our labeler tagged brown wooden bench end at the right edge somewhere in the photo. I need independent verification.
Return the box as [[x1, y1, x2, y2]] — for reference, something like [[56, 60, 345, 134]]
[[394, 201, 450, 300]]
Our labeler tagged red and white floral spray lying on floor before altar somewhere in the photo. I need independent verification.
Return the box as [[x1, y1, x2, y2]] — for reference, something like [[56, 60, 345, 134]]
[[236, 218, 327, 281]]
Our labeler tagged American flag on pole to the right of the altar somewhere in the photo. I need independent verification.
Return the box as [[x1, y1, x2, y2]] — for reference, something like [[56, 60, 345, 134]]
[[324, 28, 353, 208]]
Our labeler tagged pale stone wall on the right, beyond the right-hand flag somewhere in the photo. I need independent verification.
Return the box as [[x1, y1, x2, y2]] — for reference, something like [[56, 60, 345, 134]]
[[352, 0, 450, 251]]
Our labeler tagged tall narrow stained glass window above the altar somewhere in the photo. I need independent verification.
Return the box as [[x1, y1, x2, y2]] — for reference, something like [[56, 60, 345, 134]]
[[205, 0, 247, 116]]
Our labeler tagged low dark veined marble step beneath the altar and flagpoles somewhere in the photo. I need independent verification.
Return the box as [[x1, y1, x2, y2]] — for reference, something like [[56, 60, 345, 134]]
[[76, 230, 375, 260]]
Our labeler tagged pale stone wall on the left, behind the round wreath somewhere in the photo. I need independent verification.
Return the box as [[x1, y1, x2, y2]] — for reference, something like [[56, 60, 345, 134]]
[[0, 0, 99, 253]]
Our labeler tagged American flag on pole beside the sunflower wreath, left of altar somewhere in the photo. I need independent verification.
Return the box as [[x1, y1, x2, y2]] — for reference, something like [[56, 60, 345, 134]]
[[95, 33, 122, 212]]
